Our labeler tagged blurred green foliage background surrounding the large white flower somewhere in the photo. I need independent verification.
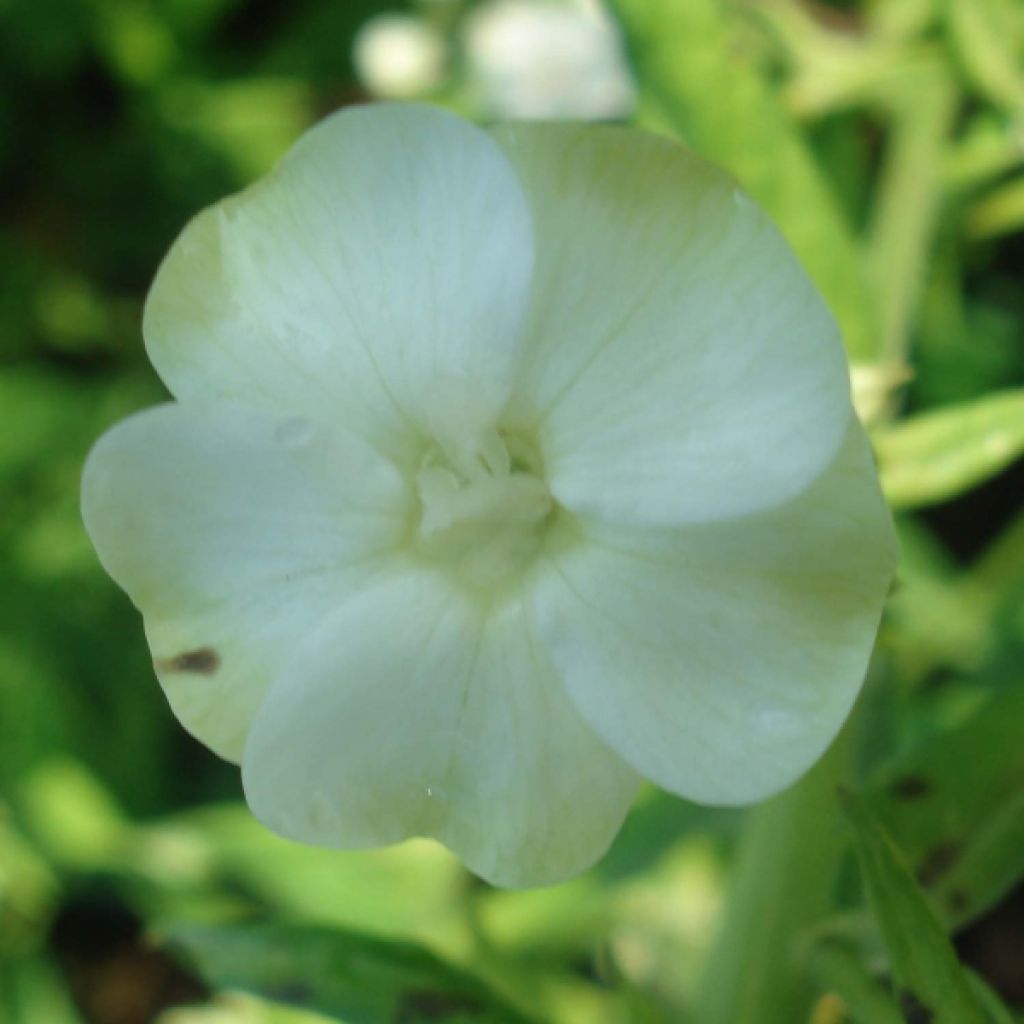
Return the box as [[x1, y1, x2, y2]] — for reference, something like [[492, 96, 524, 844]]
[[0, 0, 1024, 1024]]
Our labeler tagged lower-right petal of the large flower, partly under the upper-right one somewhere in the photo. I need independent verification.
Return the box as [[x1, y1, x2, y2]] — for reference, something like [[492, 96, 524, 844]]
[[534, 425, 897, 804]]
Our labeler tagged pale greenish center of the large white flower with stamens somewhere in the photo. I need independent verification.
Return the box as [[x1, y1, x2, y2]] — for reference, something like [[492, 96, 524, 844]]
[[416, 430, 554, 590]]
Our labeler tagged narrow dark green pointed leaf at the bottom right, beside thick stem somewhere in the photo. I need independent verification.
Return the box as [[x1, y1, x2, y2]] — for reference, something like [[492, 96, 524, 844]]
[[842, 792, 987, 1024]]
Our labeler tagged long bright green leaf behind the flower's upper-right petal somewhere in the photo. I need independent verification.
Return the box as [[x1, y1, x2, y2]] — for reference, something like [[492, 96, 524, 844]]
[[611, 0, 878, 361]]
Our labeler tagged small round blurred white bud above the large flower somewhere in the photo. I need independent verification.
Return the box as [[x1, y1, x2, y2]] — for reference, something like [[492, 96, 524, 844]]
[[354, 13, 444, 99]]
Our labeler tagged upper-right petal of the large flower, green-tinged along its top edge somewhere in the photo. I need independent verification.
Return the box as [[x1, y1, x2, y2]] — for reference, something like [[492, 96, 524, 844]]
[[494, 124, 850, 525]]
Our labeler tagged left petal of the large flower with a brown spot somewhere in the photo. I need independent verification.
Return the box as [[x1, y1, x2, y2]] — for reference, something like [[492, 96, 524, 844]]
[[82, 404, 411, 760]]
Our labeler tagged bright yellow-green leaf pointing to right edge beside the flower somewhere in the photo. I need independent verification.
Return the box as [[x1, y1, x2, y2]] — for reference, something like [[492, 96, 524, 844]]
[[873, 388, 1024, 508]]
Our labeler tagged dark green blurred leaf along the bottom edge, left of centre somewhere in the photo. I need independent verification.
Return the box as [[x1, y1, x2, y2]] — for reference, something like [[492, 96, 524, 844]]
[[166, 924, 528, 1024]]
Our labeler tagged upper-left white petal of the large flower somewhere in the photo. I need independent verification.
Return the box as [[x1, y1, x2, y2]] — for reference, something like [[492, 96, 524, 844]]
[[144, 104, 534, 455]]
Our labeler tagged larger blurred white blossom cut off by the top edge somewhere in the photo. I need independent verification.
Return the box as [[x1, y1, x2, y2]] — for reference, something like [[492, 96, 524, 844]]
[[465, 0, 634, 118]]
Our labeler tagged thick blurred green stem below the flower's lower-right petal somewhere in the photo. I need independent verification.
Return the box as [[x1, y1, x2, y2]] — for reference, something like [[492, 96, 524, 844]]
[[692, 723, 853, 1024]]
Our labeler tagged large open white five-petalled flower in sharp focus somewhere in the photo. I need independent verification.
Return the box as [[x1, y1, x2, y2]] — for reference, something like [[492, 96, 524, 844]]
[[83, 104, 895, 886]]
